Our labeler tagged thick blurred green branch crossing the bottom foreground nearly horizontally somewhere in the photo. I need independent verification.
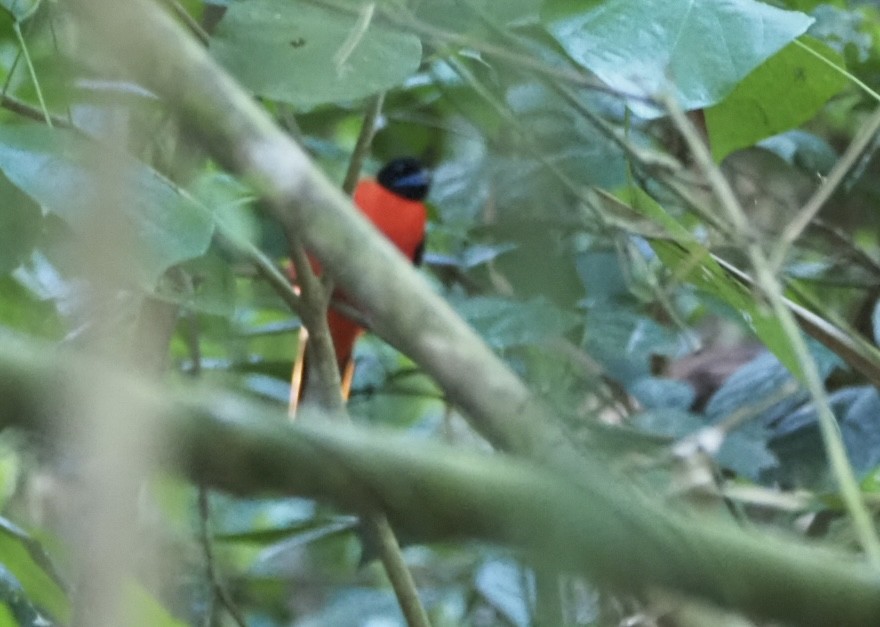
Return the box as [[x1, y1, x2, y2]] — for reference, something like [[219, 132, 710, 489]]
[[0, 338, 880, 627]]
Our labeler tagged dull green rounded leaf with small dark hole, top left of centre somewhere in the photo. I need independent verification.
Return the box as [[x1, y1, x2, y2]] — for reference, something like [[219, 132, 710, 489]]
[[211, 0, 422, 108]]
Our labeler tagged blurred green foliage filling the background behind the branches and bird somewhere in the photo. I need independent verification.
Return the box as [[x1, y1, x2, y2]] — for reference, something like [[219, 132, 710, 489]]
[[0, 0, 880, 627]]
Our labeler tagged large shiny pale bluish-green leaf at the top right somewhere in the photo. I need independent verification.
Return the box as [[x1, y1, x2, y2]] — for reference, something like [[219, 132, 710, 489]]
[[542, 0, 813, 116]]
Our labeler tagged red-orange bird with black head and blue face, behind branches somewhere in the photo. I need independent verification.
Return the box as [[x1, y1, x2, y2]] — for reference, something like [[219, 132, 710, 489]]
[[290, 157, 431, 415]]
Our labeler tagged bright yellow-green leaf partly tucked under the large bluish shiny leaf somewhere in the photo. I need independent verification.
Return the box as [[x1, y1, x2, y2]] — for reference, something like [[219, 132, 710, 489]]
[[705, 37, 846, 161]]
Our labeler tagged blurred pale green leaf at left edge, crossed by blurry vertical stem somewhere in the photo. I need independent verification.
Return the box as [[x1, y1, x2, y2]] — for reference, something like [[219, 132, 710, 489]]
[[0, 125, 214, 289]]
